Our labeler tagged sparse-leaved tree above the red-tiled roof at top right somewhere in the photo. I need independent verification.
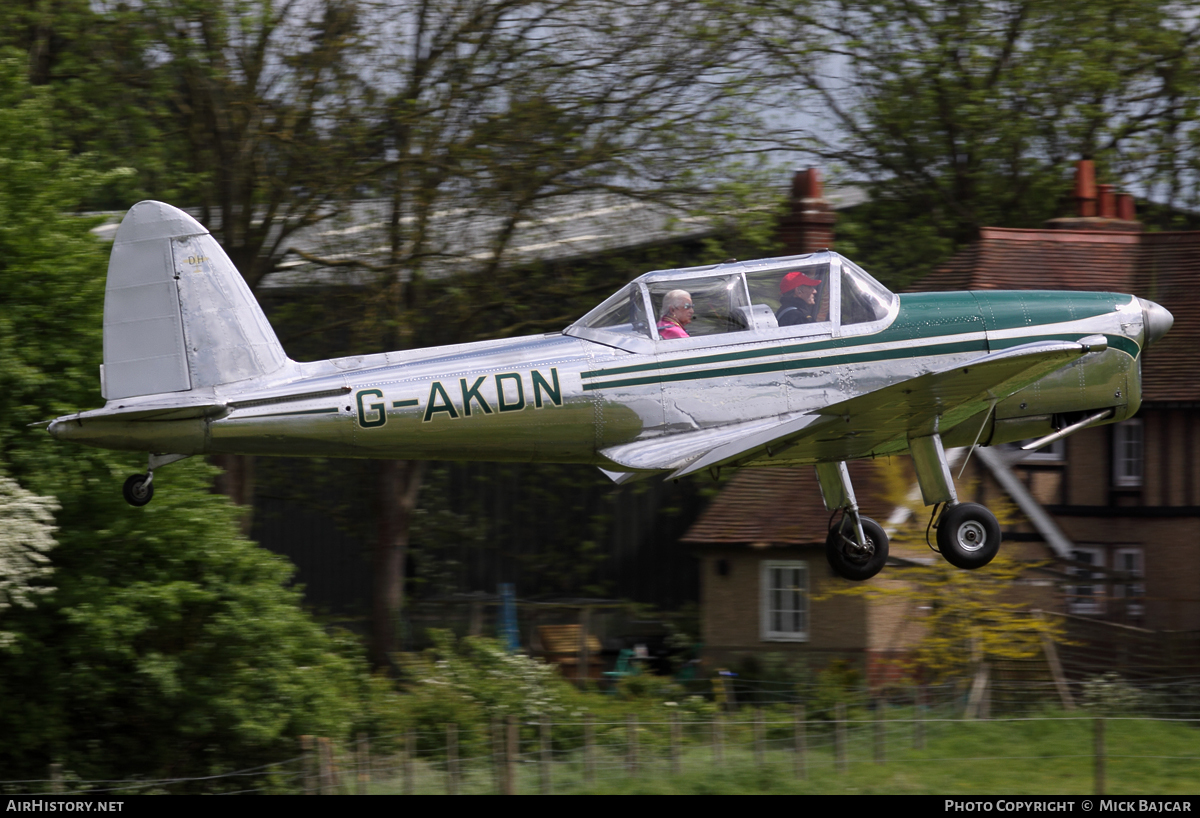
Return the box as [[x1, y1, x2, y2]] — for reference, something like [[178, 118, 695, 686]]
[[758, 0, 1200, 285]]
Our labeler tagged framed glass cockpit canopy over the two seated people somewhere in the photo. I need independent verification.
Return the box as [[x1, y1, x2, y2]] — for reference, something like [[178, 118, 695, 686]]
[[564, 251, 899, 353]]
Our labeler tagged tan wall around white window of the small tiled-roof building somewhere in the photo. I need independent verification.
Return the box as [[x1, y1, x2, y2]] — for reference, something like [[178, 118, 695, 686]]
[[700, 546, 868, 669]]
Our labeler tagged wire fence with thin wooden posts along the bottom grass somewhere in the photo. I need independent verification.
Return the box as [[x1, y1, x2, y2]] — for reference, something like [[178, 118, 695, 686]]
[[14, 696, 1200, 796]]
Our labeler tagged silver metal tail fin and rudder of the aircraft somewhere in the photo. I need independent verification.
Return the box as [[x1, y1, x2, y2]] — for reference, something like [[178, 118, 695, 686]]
[[100, 202, 288, 401]]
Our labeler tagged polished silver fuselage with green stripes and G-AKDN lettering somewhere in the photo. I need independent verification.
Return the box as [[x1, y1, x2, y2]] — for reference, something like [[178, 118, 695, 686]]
[[50, 291, 1162, 471]]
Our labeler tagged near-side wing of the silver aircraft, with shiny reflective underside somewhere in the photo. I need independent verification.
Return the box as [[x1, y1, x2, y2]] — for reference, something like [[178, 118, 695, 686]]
[[671, 337, 1103, 479]]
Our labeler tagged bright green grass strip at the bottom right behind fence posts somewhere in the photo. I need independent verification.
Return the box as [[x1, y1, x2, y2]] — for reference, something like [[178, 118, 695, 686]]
[[371, 714, 1200, 795]]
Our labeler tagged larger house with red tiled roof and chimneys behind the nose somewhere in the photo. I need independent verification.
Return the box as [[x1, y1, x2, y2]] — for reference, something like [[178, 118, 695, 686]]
[[914, 161, 1200, 631]]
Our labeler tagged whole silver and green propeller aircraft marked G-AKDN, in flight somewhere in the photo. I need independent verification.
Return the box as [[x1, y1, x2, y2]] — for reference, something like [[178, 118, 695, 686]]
[[49, 202, 1172, 579]]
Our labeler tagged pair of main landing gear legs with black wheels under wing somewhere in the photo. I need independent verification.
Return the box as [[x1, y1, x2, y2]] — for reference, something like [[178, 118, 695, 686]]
[[816, 434, 1001, 582]]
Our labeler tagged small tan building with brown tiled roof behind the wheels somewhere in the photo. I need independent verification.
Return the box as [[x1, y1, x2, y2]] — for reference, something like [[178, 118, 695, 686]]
[[684, 461, 931, 670]]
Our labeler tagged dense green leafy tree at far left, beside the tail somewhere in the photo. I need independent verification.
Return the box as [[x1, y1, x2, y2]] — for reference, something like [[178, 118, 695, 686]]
[[0, 53, 373, 789]]
